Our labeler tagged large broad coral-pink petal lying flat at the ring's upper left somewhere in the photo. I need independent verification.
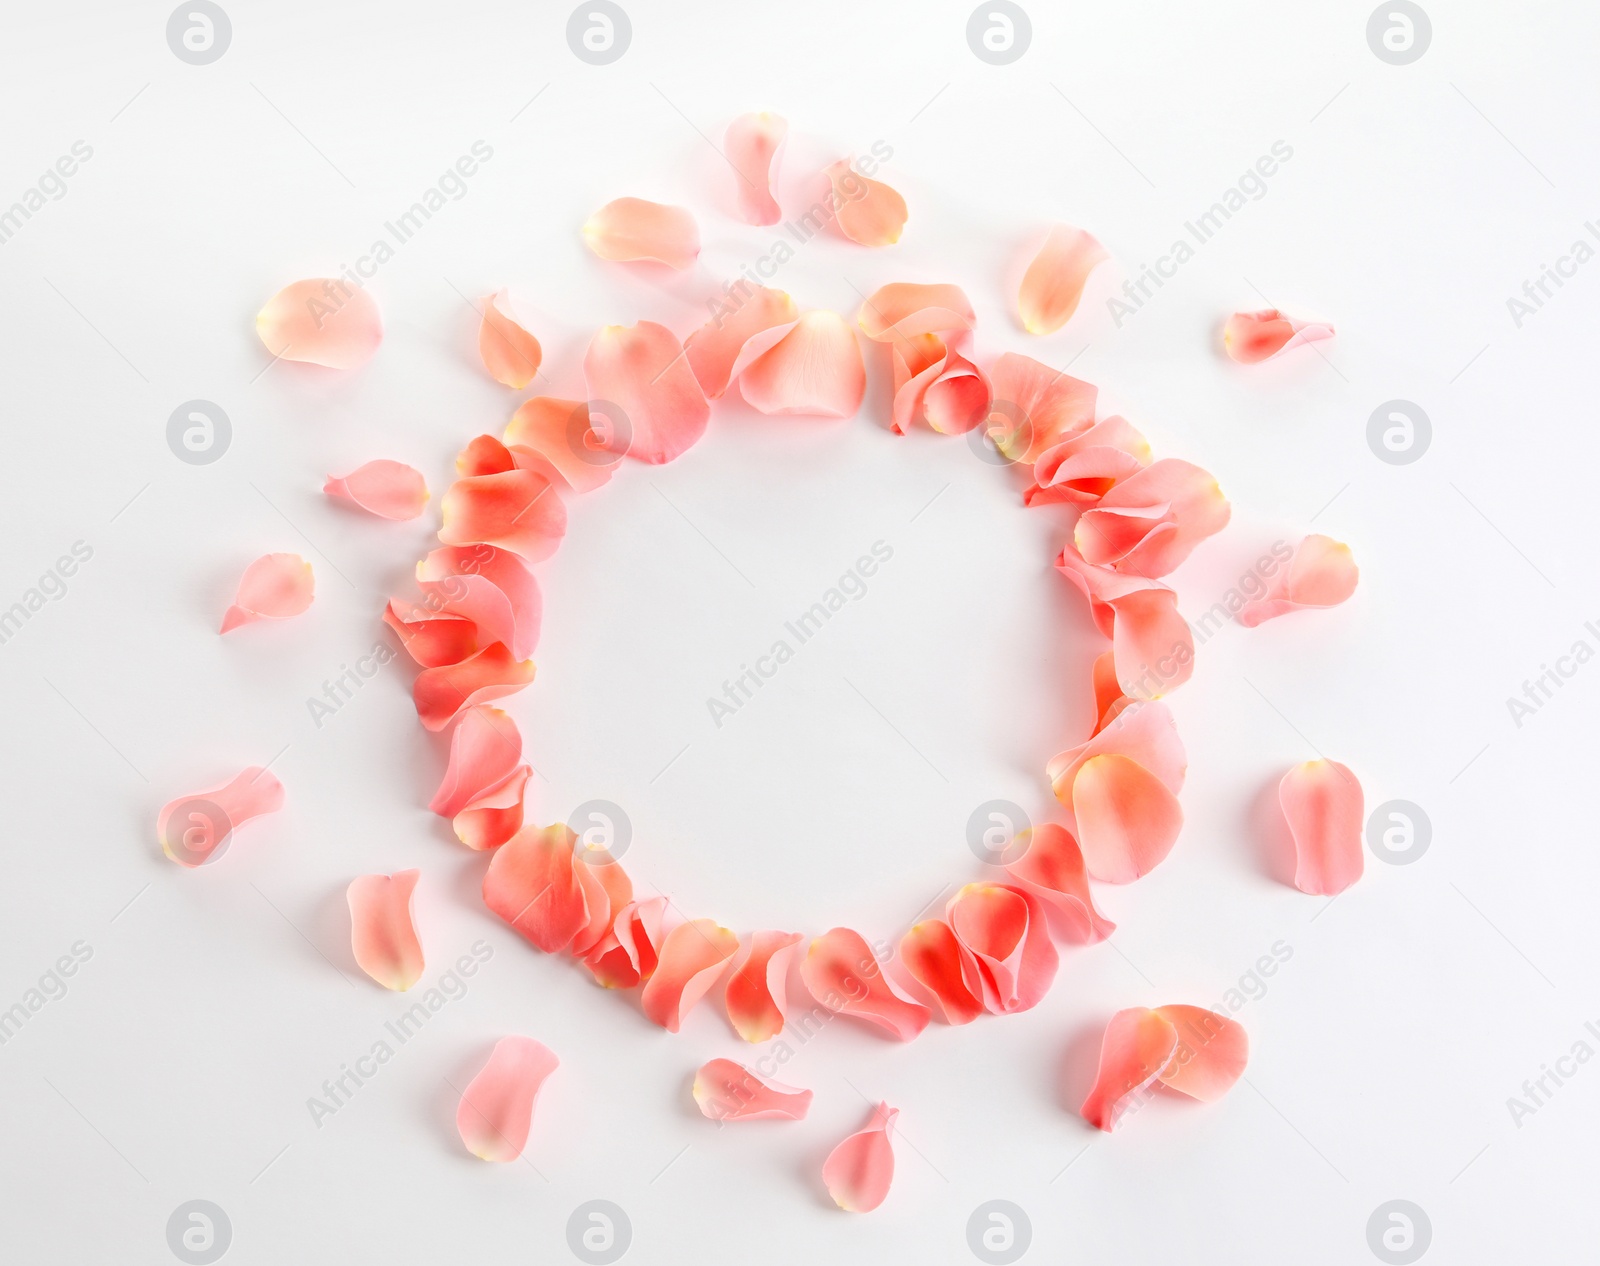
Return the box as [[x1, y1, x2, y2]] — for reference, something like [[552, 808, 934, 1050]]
[[584, 322, 710, 466]]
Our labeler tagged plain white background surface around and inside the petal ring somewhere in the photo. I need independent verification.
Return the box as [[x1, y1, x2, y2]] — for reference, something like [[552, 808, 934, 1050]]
[[0, 0, 1600, 1264]]
